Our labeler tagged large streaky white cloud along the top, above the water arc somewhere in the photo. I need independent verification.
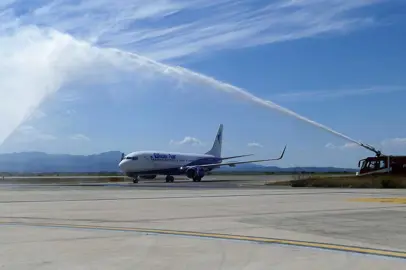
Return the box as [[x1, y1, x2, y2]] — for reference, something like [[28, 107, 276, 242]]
[[3, 0, 388, 60]]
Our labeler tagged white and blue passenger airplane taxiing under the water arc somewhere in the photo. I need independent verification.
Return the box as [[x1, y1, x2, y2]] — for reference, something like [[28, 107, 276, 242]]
[[118, 124, 286, 183]]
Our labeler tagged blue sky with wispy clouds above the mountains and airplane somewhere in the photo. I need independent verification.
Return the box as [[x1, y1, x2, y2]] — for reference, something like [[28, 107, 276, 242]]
[[0, 0, 406, 167]]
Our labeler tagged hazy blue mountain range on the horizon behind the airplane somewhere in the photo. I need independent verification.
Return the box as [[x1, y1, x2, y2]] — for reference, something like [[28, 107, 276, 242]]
[[0, 151, 356, 173]]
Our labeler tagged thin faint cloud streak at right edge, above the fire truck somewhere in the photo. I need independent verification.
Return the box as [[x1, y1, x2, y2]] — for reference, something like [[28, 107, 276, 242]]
[[272, 86, 406, 102]]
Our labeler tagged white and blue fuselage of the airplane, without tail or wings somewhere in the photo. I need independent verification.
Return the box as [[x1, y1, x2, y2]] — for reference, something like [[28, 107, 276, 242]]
[[119, 151, 221, 175]]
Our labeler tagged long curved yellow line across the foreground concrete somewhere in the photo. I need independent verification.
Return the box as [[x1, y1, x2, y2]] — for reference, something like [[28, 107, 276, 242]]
[[0, 222, 406, 259]]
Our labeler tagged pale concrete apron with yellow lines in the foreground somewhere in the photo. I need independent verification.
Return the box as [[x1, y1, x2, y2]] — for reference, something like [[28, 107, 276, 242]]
[[0, 176, 406, 269]]
